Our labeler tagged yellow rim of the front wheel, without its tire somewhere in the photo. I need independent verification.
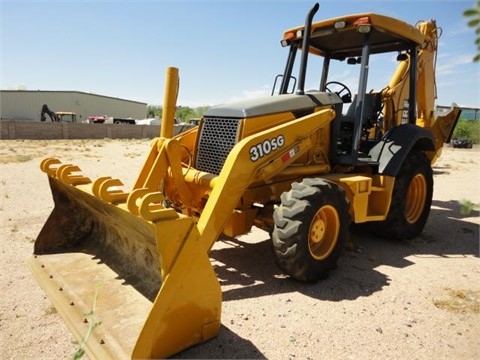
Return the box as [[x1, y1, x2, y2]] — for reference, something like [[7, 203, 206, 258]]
[[308, 205, 340, 260]]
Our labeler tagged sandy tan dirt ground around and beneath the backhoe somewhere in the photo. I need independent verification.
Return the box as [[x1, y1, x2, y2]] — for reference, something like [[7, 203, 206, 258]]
[[0, 140, 480, 360]]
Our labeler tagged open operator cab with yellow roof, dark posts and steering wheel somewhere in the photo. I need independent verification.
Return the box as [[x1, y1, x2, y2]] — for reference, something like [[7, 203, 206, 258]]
[[274, 4, 426, 166]]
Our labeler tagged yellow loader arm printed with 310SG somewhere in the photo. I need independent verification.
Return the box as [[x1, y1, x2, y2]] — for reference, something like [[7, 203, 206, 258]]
[[197, 109, 335, 249]]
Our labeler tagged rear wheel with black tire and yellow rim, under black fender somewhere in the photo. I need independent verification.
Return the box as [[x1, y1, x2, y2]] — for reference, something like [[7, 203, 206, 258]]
[[370, 151, 433, 240]]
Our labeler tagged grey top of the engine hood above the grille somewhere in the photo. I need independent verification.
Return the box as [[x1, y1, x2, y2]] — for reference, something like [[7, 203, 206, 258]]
[[203, 91, 342, 118]]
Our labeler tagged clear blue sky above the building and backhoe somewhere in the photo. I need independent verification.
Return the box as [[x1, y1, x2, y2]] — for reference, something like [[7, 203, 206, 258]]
[[0, 0, 480, 107]]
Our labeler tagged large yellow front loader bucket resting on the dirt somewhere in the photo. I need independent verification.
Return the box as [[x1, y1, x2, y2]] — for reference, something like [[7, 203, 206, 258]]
[[27, 173, 221, 359]]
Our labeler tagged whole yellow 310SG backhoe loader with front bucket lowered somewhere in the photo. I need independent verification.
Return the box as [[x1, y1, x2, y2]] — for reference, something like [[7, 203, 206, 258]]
[[28, 4, 460, 359]]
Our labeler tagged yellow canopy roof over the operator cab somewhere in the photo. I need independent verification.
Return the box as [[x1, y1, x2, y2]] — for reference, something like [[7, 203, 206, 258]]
[[283, 13, 429, 60]]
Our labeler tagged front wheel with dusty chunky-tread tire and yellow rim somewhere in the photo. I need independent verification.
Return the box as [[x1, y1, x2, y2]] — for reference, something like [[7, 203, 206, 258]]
[[272, 179, 351, 282]]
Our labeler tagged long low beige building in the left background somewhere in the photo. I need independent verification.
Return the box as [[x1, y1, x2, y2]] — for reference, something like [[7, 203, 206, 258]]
[[0, 90, 147, 121]]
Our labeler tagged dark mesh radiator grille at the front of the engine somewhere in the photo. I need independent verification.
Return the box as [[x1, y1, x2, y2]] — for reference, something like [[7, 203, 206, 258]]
[[195, 118, 240, 175]]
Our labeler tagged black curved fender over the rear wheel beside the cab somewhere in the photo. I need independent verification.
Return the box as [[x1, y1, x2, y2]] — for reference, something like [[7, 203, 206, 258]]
[[369, 124, 435, 176]]
